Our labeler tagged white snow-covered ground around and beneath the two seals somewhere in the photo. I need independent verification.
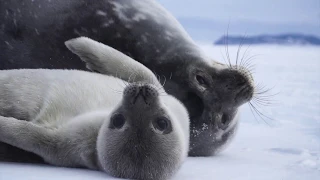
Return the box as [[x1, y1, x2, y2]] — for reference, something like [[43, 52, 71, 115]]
[[0, 44, 320, 180]]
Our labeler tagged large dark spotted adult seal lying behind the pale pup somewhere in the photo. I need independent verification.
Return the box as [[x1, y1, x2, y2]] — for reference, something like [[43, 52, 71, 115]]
[[0, 0, 253, 156]]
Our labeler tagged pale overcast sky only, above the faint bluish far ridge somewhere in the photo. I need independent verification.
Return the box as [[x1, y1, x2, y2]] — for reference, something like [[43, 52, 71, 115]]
[[158, 0, 320, 27]]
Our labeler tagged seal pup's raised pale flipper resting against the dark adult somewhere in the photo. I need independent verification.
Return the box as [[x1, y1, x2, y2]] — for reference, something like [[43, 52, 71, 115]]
[[65, 37, 162, 88]]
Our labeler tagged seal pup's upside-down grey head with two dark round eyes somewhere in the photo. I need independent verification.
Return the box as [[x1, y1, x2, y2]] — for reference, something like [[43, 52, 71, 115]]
[[97, 83, 189, 179]]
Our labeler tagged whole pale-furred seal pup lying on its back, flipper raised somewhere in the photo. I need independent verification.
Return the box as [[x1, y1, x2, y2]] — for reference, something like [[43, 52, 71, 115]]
[[0, 38, 189, 180]]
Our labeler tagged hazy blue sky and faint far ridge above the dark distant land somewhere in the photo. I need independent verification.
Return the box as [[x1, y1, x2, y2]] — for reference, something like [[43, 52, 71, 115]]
[[158, 0, 320, 42]]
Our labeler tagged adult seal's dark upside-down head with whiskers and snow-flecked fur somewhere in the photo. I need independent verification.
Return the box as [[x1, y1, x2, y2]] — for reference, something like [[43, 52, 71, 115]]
[[185, 59, 254, 156]]
